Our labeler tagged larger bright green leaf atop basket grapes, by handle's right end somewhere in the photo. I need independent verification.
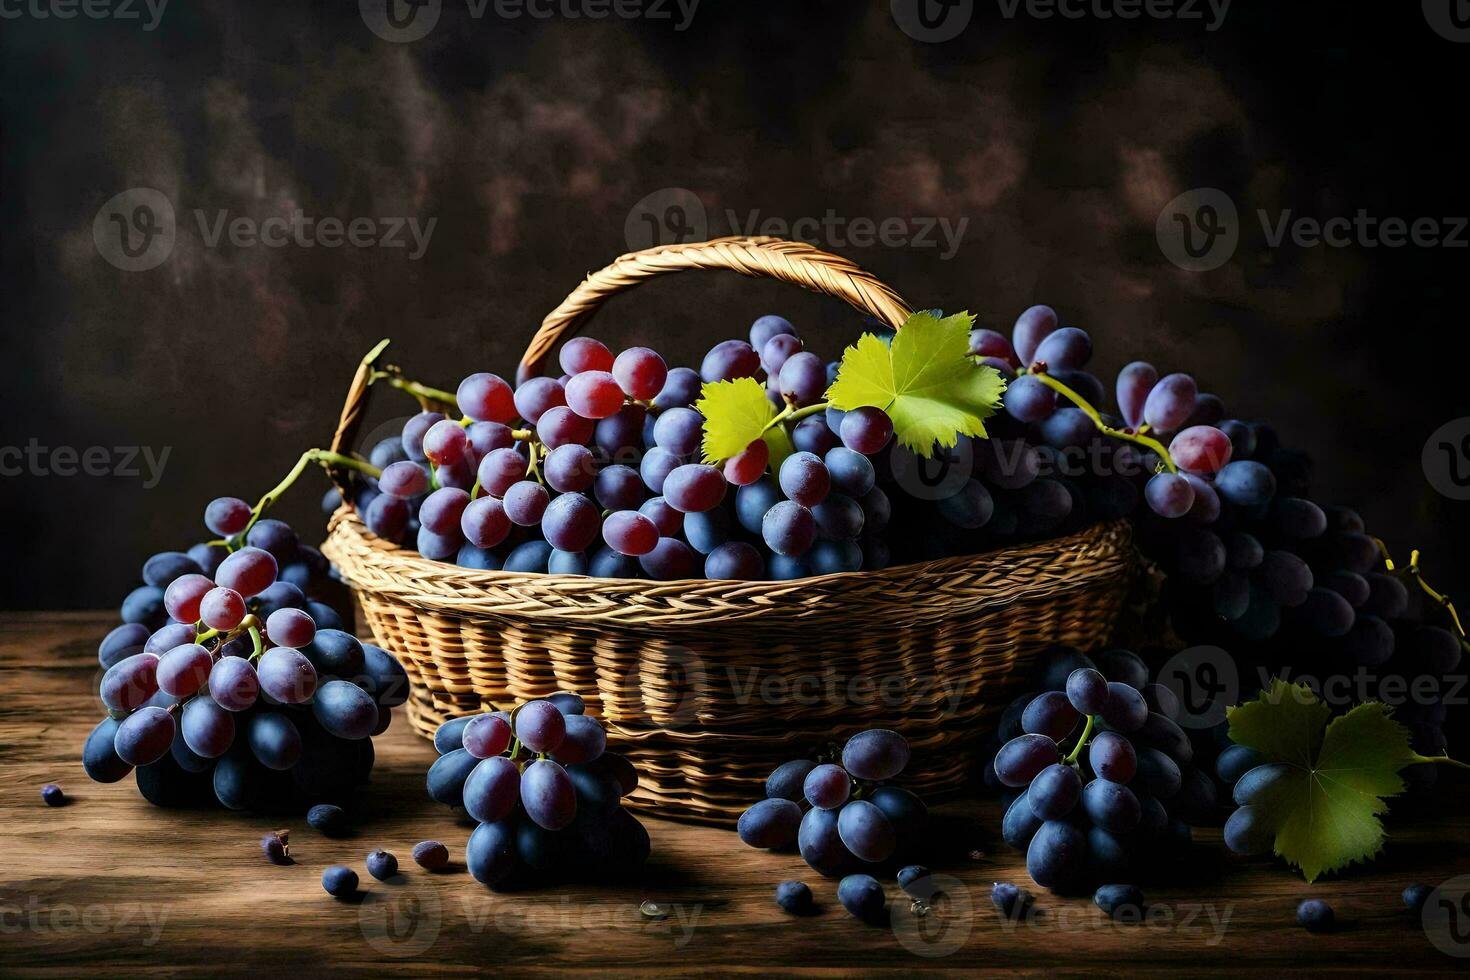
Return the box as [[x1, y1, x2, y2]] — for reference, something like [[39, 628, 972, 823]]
[[826, 310, 1005, 457]]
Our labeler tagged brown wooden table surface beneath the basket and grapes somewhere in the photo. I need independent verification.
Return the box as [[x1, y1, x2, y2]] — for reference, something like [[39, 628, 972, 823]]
[[0, 613, 1470, 977]]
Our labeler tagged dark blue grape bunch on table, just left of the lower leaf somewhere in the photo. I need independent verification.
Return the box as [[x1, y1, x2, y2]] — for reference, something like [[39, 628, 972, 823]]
[[985, 646, 1217, 890]]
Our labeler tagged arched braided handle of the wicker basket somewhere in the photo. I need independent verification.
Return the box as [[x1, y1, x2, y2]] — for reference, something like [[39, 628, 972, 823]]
[[516, 237, 910, 383]]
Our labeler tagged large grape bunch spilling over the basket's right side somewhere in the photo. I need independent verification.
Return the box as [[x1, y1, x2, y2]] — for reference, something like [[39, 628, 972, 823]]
[[972, 307, 1466, 786]]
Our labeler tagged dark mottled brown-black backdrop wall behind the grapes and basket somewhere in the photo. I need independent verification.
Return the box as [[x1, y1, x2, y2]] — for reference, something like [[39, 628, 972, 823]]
[[0, 0, 1470, 608]]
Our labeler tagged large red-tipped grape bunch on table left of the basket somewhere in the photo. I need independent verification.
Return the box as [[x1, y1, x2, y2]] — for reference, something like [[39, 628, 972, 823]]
[[82, 497, 409, 811]]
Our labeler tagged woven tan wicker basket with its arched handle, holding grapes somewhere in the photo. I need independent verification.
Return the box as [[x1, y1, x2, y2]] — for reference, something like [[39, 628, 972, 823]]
[[323, 238, 1135, 823]]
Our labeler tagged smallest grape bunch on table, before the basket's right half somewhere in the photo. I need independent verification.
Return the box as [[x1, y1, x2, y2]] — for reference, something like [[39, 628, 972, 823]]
[[738, 729, 929, 877]]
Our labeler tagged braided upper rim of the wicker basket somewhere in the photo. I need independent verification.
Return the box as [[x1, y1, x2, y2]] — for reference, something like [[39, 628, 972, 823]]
[[322, 504, 1132, 626]]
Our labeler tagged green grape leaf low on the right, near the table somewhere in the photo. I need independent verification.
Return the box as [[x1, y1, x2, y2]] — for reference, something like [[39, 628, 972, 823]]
[[1229, 677, 1423, 882]]
